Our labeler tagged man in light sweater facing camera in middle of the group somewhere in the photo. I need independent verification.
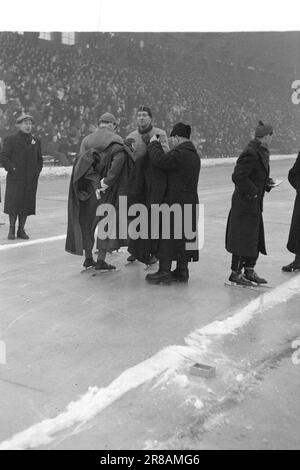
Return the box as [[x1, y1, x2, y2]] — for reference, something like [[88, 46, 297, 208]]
[[126, 106, 170, 264]]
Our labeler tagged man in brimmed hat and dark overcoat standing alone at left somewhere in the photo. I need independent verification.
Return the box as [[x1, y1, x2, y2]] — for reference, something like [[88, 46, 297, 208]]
[[0, 114, 43, 240]]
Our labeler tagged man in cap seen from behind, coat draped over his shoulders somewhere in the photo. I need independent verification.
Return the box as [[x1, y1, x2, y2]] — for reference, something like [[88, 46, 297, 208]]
[[65, 113, 133, 270]]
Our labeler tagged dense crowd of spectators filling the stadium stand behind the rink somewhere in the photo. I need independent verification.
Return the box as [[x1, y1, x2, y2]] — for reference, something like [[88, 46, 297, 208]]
[[0, 32, 300, 164]]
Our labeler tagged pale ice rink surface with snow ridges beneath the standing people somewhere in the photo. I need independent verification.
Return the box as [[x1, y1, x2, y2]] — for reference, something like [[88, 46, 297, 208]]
[[0, 159, 300, 449]]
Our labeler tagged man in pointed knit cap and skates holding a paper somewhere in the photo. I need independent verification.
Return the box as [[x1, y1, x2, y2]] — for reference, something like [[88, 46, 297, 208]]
[[226, 121, 274, 285]]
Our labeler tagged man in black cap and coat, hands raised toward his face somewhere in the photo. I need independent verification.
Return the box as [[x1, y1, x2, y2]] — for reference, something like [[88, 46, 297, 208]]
[[139, 123, 201, 284]]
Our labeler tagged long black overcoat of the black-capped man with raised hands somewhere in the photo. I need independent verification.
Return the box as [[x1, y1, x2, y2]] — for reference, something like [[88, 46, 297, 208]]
[[129, 141, 201, 262]]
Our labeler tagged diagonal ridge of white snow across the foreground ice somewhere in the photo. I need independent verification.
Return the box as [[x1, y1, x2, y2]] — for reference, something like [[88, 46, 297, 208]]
[[0, 275, 300, 450]]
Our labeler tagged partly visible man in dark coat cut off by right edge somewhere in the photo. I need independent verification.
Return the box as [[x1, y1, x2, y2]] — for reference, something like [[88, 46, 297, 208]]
[[282, 152, 300, 272]]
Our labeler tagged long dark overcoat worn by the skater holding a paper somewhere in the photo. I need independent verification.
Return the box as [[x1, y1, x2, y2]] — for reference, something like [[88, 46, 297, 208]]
[[226, 139, 271, 257]]
